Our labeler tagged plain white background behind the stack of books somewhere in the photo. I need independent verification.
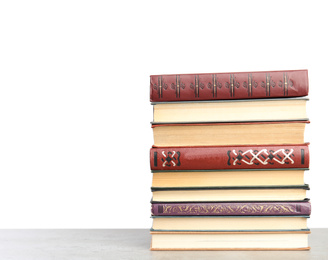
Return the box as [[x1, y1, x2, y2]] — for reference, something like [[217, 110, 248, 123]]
[[0, 0, 328, 228]]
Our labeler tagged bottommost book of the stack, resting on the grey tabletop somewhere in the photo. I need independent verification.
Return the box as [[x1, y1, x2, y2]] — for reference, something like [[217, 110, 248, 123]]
[[150, 230, 310, 250]]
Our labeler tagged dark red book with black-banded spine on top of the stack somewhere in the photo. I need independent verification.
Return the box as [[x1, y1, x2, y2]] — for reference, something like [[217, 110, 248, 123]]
[[150, 70, 309, 102]]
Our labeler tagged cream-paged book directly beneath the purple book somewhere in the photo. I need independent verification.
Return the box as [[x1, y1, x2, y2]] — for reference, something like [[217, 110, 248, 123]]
[[151, 215, 309, 231]]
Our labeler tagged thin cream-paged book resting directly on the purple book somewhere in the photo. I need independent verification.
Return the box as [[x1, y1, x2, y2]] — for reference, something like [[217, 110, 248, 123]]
[[151, 184, 310, 202]]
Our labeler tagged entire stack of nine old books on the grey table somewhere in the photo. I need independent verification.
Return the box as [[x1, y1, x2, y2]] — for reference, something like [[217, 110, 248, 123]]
[[150, 70, 311, 250]]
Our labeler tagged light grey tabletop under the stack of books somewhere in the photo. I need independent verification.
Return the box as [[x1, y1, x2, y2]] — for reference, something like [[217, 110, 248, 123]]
[[0, 229, 328, 260]]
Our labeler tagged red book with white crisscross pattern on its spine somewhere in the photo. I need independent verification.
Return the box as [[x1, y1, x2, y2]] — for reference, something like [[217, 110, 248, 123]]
[[150, 143, 309, 171]]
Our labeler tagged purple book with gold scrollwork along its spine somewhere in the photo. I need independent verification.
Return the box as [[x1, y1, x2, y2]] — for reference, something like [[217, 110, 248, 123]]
[[151, 201, 311, 216]]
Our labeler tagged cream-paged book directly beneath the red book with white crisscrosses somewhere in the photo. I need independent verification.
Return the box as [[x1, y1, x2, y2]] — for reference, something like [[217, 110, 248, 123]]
[[152, 169, 305, 187]]
